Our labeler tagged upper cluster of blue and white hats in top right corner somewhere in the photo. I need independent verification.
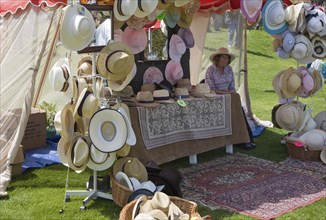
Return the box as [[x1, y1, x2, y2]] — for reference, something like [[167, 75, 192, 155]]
[[262, 0, 326, 64]]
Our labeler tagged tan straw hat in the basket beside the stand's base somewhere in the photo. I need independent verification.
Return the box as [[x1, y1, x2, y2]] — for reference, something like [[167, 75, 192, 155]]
[[113, 157, 148, 182]]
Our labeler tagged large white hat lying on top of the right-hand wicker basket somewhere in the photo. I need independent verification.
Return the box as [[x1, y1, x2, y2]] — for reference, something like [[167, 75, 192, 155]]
[[299, 129, 326, 150]]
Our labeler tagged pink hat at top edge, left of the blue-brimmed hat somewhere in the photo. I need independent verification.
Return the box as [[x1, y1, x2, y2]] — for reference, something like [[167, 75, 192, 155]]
[[240, 0, 263, 22]]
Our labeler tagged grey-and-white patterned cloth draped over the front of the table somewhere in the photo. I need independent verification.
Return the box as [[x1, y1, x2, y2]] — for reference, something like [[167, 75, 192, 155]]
[[137, 95, 232, 149]]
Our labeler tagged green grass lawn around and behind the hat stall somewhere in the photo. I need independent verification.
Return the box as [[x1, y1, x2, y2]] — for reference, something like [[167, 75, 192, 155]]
[[0, 29, 326, 220]]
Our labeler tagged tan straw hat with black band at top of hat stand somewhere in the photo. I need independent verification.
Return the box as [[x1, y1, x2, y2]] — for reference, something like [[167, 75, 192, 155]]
[[97, 42, 135, 80]]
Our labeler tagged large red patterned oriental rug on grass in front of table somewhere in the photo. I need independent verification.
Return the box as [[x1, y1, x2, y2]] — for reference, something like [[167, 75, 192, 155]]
[[179, 153, 326, 219]]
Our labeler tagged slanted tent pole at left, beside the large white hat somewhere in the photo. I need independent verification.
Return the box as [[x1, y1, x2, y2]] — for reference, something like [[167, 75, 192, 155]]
[[32, 6, 63, 108]]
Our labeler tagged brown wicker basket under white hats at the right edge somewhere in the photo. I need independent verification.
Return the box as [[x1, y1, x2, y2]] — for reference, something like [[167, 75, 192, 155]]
[[285, 137, 321, 161]]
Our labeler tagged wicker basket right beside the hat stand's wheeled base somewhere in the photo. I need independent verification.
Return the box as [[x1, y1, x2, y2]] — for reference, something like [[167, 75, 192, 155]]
[[111, 177, 133, 207]]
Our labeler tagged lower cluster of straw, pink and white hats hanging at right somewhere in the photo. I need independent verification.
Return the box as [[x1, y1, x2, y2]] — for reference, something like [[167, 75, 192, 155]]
[[272, 66, 326, 163]]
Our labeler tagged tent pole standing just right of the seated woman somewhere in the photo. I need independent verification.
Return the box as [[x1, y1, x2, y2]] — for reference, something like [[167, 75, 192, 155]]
[[243, 23, 253, 118]]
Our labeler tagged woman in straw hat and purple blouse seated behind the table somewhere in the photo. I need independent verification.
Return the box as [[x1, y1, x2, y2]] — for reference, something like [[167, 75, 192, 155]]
[[205, 47, 256, 149]]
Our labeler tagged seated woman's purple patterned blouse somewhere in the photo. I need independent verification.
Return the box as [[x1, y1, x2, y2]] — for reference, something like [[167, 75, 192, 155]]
[[205, 64, 235, 91]]
